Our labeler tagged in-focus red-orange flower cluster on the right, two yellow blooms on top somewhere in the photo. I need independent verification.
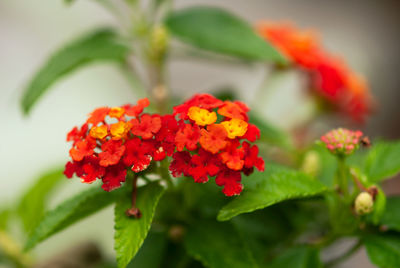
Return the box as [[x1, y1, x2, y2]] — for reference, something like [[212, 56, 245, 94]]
[[170, 94, 264, 196]]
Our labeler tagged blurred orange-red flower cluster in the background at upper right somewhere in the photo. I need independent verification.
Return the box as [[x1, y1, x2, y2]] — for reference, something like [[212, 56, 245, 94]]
[[257, 22, 372, 121]]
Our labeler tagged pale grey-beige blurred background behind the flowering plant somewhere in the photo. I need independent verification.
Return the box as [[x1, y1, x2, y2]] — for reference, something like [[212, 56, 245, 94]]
[[0, 0, 400, 267]]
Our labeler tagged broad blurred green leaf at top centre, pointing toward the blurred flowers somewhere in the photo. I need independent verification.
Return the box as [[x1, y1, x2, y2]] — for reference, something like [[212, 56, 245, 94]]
[[166, 7, 287, 64]]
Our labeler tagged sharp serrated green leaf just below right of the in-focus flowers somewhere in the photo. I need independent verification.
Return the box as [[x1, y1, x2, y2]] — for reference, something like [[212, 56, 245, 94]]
[[217, 164, 327, 221]]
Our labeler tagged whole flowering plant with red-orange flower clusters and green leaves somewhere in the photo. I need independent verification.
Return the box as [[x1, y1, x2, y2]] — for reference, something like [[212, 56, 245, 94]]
[[0, 1, 400, 268]]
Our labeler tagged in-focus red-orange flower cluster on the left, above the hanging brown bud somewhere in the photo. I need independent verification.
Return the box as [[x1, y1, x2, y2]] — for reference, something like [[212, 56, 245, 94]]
[[64, 99, 173, 191]]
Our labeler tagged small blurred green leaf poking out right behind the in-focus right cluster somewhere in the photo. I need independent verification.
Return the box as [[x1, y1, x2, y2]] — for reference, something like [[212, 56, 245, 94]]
[[249, 113, 293, 149]]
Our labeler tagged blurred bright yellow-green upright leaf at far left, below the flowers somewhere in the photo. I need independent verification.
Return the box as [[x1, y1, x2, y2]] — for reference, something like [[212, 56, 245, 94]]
[[17, 168, 65, 233]]
